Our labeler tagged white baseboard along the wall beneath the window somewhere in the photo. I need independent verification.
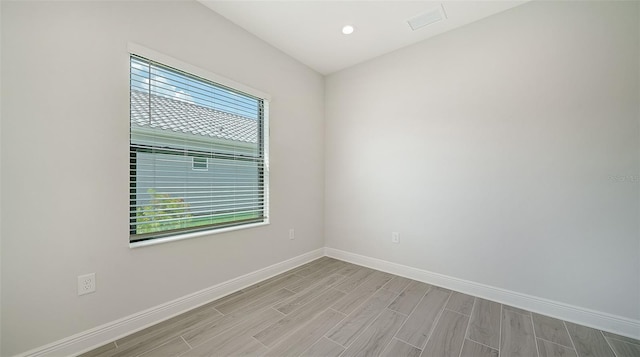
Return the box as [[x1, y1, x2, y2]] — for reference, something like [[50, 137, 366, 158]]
[[16, 248, 324, 357]]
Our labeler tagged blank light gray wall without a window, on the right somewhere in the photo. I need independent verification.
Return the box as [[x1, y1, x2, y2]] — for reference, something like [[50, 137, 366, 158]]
[[325, 1, 640, 320]]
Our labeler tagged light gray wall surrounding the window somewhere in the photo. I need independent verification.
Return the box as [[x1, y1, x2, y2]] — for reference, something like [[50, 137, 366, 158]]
[[0, 1, 324, 356]]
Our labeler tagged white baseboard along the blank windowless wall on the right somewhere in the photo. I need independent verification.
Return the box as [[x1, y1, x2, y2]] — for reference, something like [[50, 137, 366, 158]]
[[325, 248, 640, 339]]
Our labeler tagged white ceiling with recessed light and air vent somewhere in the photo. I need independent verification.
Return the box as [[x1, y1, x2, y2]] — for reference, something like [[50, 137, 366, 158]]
[[199, 0, 526, 74]]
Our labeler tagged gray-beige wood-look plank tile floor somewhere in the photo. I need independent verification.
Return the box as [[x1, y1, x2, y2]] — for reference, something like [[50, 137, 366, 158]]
[[82, 257, 640, 357]]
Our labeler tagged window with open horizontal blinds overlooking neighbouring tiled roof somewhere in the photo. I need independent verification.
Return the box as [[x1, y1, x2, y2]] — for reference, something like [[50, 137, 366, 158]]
[[129, 54, 268, 243]]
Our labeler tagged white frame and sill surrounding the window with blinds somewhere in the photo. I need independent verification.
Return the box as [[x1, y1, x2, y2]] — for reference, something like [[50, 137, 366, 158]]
[[127, 43, 271, 248]]
